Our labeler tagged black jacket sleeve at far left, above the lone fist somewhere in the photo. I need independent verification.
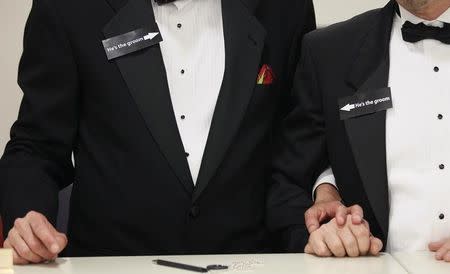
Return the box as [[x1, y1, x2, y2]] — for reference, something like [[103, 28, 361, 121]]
[[0, 0, 79, 232]]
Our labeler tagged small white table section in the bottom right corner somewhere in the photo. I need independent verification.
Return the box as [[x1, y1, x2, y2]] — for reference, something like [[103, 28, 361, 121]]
[[393, 252, 450, 274]]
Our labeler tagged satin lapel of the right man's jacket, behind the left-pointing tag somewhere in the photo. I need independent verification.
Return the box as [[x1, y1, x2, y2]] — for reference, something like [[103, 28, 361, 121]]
[[345, 1, 394, 237]]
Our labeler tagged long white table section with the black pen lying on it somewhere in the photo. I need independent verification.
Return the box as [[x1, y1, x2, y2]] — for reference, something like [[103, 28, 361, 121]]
[[14, 254, 408, 274]]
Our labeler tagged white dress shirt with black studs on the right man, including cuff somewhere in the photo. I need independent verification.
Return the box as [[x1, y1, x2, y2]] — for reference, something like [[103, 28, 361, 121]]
[[316, 7, 450, 252]]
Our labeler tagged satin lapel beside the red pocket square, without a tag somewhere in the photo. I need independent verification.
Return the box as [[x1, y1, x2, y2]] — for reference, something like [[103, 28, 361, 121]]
[[193, 0, 266, 201]]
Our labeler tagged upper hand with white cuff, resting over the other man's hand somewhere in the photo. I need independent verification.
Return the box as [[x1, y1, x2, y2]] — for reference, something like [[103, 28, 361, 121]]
[[305, 184, 364, 234]]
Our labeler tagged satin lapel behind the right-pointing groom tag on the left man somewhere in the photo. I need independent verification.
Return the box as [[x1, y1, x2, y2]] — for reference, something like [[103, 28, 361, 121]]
[[103, 0, 194, 194]]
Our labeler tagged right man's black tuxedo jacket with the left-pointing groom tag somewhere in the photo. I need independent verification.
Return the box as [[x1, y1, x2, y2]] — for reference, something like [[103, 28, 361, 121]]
[[271, 1, 395, 250]]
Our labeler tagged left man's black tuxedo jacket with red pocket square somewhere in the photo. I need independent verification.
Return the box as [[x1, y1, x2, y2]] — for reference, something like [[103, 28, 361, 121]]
[[0, 0, 315, 256]]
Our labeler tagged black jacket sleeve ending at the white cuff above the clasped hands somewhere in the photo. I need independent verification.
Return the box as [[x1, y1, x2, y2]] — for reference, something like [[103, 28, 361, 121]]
[[267, 31, 329, 252]]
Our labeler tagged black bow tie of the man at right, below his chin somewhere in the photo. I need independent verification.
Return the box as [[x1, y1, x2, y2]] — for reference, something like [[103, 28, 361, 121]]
[[402, 21, 450, 44]]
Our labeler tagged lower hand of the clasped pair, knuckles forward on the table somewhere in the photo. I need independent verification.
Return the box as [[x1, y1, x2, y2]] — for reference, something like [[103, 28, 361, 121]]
[[305, 215, 383, 257]]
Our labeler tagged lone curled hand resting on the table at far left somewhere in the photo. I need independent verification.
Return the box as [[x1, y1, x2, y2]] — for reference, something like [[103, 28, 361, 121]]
[[4, 211, 67, 264]]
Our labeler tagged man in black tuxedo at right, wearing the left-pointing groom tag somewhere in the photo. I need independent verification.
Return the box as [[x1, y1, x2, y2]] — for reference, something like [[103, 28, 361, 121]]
[[273, 0, 450, 261]]
